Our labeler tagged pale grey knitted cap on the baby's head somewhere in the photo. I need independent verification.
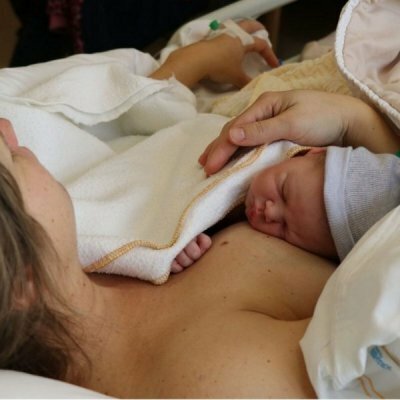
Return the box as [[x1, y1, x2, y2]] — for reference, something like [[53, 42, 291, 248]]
[[324, 146, 400, 260]]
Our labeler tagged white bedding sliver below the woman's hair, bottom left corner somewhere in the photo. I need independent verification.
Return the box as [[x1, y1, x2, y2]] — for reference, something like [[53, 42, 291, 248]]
[[0, 370, 110, 399]]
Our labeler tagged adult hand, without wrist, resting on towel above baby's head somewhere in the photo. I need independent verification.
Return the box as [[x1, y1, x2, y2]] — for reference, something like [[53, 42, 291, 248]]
[[199, 90, 354, 175]]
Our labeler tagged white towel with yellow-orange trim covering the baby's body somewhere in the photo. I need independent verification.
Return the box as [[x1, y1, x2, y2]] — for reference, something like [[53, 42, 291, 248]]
[[68, 119, 291, 283]]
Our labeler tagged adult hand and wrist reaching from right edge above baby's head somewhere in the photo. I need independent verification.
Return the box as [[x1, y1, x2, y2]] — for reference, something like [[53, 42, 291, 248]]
[[199, 90, 400, 175]]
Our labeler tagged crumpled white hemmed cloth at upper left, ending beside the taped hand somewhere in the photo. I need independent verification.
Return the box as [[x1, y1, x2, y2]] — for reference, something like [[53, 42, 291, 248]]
[[0, 49, 196, 134]]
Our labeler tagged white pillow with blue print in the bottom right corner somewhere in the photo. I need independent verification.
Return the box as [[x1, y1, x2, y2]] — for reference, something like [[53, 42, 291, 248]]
[[301, 206, 400, 398]]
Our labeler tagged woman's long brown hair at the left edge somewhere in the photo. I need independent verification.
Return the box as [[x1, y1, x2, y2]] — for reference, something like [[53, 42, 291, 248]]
[[0, 164, 80, 379]]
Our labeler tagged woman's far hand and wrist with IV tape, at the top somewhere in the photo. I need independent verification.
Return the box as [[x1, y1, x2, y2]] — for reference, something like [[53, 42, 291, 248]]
[[151, 20, 279, 88]]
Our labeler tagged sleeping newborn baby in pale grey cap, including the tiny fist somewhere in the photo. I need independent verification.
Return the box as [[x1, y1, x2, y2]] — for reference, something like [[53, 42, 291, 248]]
[[174, 146, 400, 270]]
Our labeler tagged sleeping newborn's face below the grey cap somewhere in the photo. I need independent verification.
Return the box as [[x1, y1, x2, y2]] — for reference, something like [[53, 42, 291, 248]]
[[245, 152, 337, 257]]
